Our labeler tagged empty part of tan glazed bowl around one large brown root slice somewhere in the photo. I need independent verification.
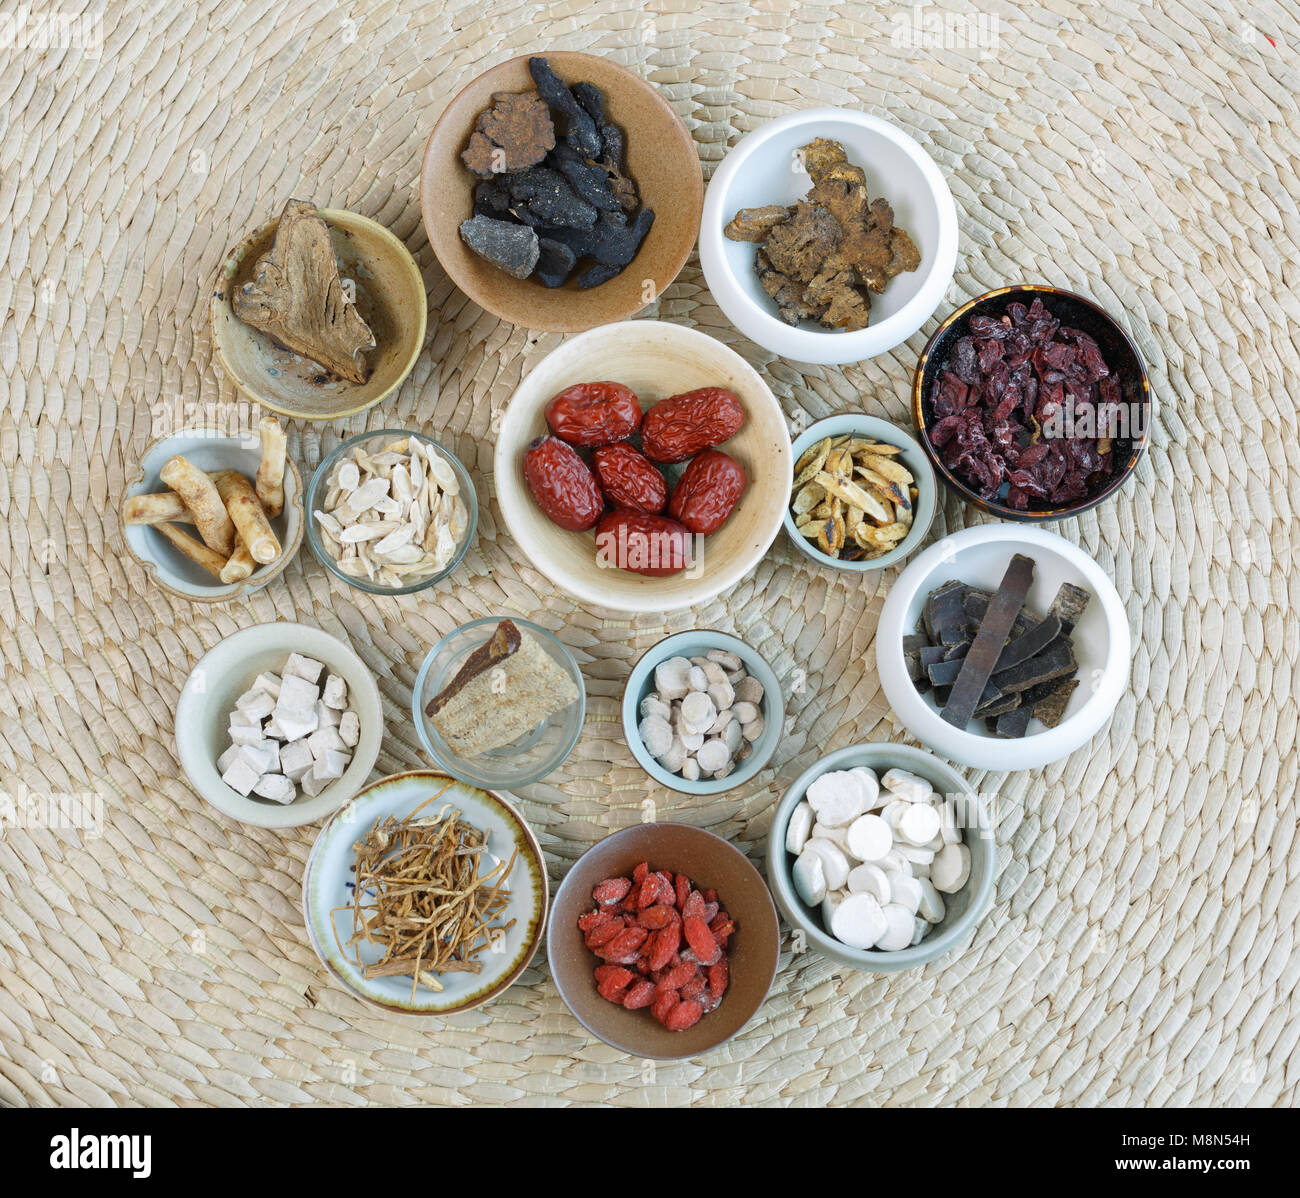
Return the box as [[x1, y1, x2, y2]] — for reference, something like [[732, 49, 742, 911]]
[[209, 208, 429, 420]]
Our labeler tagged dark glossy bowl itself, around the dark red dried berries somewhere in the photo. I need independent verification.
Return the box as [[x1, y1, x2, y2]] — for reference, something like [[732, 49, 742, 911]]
[[911, 283, 1154, 524]]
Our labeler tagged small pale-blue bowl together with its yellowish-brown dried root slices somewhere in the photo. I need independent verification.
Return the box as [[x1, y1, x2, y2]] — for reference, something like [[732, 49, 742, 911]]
[[784, 412, 937, 573]]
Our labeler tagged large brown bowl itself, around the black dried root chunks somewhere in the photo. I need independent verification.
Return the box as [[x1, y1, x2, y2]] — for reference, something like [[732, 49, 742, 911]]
[[420, 51, 705, 333]]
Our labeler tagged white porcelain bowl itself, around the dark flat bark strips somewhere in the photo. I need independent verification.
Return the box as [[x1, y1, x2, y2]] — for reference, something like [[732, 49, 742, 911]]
[[876, 524, 1132, 769]]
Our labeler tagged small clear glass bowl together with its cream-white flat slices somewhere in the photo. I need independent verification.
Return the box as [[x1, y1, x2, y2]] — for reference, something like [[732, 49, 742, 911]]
[[307, 429, 478, 595]]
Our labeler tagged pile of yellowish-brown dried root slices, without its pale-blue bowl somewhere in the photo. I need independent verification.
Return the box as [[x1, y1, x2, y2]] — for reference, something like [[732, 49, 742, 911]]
[[790, 437, 918, 561]]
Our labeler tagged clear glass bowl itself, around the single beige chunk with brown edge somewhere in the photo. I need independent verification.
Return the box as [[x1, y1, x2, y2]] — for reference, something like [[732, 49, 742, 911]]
[[411, 616, 586, 790]]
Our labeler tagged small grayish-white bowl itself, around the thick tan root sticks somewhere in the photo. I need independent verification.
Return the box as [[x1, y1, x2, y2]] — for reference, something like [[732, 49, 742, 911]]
[[118, 427, 306, 603]]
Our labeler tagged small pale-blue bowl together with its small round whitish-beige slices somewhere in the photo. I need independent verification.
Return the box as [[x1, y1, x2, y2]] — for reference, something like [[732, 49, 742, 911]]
[[623, 629, 785, 794]]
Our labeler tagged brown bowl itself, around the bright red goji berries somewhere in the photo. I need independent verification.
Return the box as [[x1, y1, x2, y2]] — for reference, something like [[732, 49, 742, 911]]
[[546, 824, 781, 1060]]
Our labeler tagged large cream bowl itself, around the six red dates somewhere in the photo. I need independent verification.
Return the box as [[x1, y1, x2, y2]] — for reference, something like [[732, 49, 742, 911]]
[[494, 320, 792, 612]]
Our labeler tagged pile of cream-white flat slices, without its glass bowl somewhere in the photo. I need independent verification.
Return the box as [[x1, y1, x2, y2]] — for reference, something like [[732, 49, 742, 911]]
[[312, 437, 469, 587]]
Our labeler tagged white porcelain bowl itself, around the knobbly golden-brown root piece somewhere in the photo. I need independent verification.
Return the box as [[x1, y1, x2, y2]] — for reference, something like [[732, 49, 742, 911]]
[[699, 108, 957, 364]]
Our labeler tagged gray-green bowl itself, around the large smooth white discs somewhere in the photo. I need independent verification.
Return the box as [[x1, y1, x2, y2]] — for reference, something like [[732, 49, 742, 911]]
[[767, 742, 997, 973]]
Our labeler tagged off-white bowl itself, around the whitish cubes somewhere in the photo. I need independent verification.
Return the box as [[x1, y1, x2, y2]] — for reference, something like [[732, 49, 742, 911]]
[[176, 624, 384, 828]]
